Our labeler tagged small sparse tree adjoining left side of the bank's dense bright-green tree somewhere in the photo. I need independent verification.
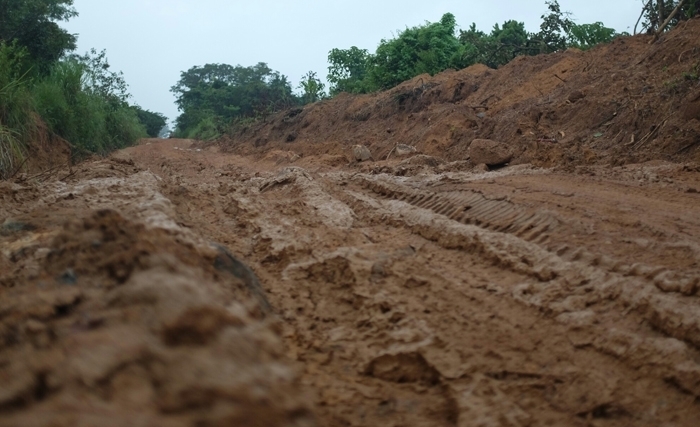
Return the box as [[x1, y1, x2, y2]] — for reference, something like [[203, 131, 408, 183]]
[[327, 46, 375, 95]]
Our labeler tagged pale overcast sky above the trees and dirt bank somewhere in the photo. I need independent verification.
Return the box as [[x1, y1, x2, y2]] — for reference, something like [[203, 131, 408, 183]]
[[62, 0, 643, 125]]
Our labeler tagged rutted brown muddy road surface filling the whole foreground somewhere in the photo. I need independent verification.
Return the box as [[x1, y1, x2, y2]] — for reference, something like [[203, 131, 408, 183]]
[[0, 140, 700, 426]]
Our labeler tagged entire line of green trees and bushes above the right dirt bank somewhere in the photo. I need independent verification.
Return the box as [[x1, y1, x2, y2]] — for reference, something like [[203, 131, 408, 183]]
[[171, 0, 700, 139]]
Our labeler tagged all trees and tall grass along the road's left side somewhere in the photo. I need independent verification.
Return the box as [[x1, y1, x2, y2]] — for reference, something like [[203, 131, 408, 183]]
[[0, 0, 166, 178]]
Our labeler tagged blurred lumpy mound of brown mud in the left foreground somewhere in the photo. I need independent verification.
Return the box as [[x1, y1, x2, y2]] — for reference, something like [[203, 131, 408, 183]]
[[0, 159, 315, 427]]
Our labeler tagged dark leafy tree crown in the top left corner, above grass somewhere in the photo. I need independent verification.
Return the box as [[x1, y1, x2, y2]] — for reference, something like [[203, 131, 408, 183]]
[[0, 0, 78, 72]]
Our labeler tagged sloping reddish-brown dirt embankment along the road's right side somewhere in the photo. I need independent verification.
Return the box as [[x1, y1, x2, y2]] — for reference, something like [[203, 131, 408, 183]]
[[221, 18, 700, 166]]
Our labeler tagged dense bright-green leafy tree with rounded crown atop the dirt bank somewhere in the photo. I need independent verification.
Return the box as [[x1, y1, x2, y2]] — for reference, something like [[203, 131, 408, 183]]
[[369, 13, 464, 89]]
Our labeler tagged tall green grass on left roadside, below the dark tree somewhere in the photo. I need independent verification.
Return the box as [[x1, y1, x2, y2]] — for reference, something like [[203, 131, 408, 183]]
[[0, 42, 146, 179]]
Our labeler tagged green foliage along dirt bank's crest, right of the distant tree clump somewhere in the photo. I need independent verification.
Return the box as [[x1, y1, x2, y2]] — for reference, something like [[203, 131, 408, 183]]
[[327, 0, 619, 95]]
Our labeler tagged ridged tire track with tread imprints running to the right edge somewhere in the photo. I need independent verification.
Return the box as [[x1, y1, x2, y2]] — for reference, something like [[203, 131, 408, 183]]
[[346, 173, 700, 398]]
